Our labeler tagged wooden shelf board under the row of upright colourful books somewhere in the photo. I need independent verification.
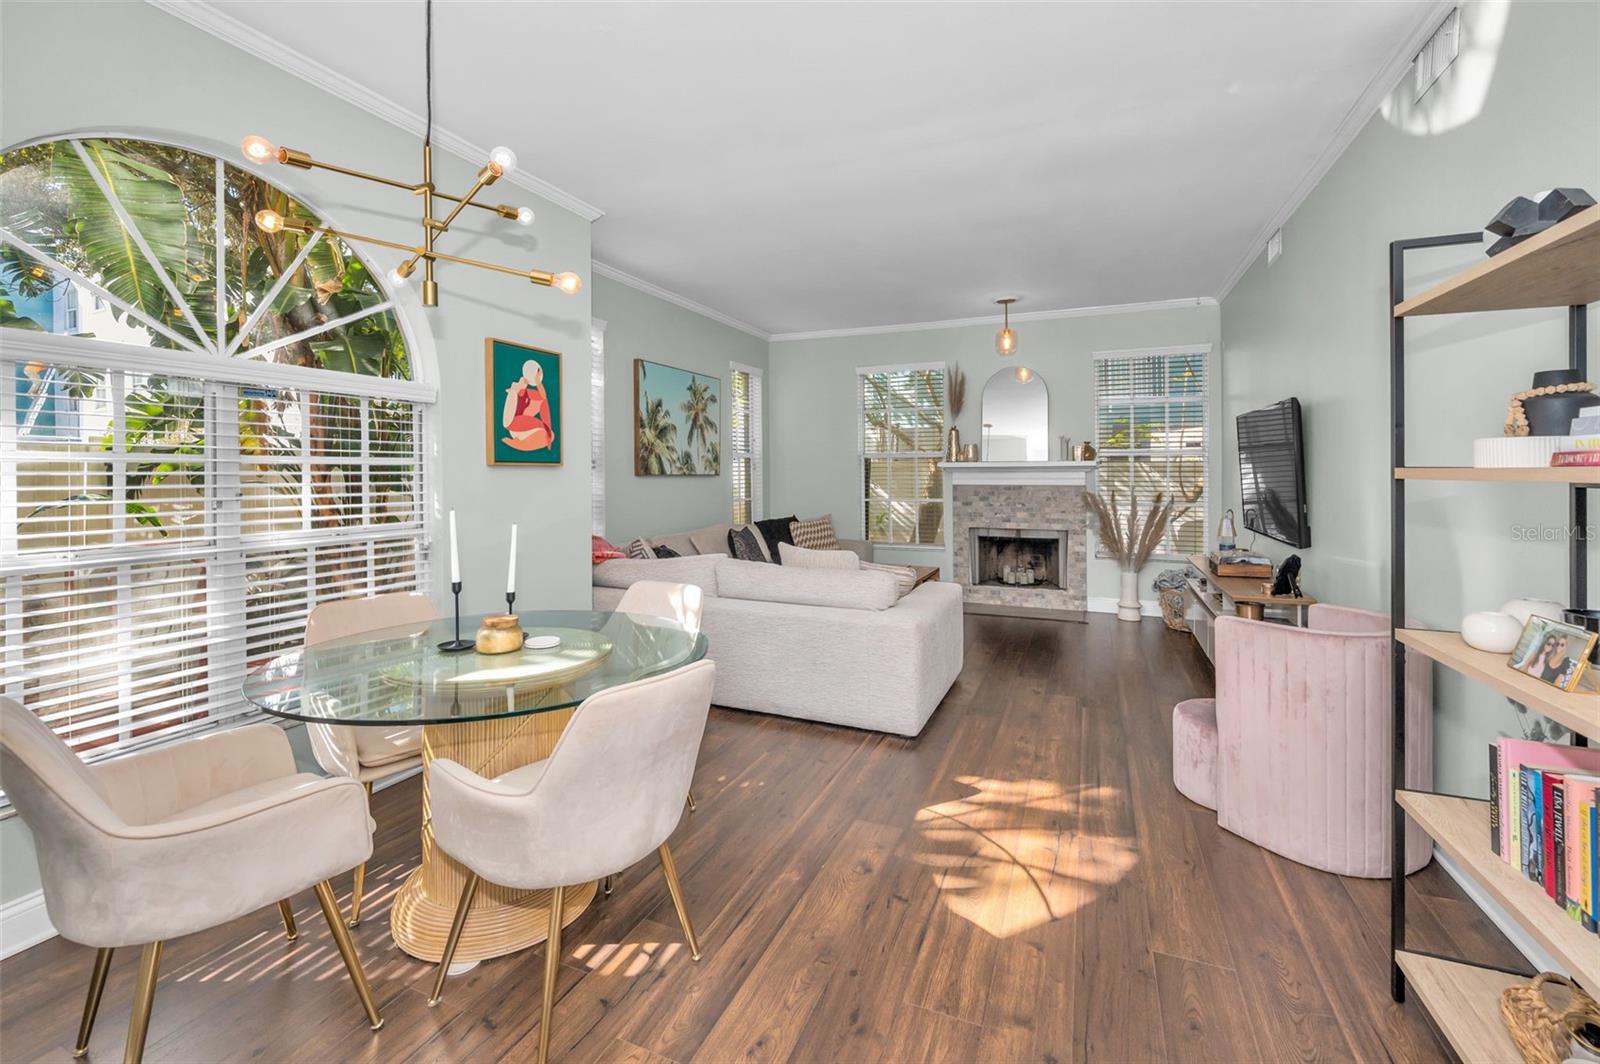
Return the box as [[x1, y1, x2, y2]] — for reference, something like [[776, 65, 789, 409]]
[[1395, 790, 1600, 987]]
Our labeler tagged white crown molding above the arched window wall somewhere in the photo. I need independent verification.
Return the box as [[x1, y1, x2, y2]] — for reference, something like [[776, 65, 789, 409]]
[[146, 0, 605, 221]]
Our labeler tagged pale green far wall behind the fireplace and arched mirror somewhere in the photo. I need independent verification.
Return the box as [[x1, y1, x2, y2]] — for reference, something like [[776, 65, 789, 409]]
[[766, 304, 1226, 598]]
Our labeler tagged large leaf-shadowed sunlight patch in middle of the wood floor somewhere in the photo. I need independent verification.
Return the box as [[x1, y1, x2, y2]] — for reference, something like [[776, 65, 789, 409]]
[[917, 776, 1139, 938]]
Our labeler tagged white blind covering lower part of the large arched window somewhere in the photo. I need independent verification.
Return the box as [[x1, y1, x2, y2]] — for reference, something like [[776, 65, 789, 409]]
[[0, 358, 427, 760]]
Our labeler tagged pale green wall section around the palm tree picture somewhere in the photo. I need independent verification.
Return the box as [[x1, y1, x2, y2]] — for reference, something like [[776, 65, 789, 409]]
[[594, 275, 768, 546]]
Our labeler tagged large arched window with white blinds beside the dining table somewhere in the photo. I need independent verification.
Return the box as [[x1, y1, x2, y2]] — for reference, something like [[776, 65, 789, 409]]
[[0, 136, 432, 758]]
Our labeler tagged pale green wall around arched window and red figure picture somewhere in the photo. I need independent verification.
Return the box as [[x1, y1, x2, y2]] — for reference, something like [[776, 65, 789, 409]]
[[0, 3, 590, 901]]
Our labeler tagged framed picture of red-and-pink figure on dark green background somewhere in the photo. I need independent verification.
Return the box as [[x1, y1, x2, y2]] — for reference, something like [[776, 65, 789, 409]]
[[483, 338, 562, 466]]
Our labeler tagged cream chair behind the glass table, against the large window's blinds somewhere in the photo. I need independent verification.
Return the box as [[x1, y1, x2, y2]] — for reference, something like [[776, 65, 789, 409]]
[[306, 592, 437, 928]]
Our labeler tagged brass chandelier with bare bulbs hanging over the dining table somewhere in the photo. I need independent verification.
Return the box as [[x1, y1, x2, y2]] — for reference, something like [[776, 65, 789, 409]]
[[238, 0, 584, 307]]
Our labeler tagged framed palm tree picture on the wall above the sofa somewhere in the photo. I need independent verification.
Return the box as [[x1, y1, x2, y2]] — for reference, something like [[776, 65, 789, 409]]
[[634, 358, 722, 477]]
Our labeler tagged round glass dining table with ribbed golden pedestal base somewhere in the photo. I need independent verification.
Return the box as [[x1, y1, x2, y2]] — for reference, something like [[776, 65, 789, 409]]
[[243, 611, 707, 963]]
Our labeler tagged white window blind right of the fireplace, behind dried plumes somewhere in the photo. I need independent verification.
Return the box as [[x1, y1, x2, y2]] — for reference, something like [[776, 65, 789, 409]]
[[1094, 344, 1211, 557]]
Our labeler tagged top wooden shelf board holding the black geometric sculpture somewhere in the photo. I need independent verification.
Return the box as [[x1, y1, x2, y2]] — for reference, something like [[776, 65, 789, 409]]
[[1394, 206, 1600, 318]]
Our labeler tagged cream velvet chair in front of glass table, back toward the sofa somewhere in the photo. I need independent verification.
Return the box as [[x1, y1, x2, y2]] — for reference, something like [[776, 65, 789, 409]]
[[429, 661, 717, 1064]]
